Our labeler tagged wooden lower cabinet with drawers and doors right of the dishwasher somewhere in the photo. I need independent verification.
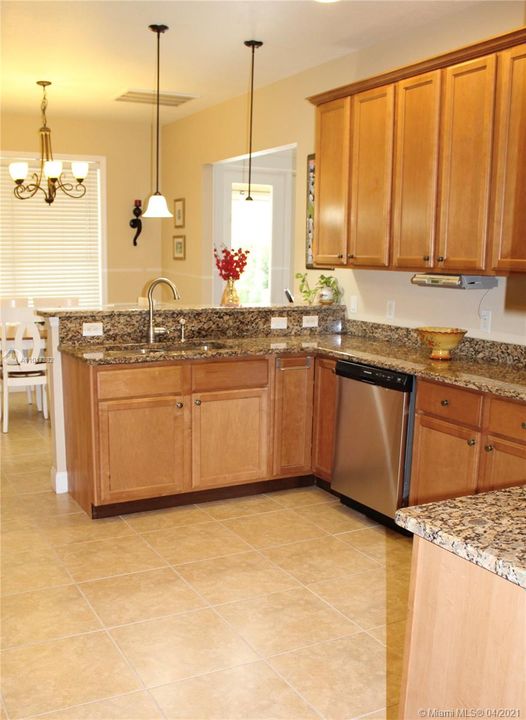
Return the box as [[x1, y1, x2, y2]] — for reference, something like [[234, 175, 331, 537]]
[[409, 380, 526, 505]]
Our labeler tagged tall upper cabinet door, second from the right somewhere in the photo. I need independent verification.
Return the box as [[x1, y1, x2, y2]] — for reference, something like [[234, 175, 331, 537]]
[[436, 55, 496, 270]]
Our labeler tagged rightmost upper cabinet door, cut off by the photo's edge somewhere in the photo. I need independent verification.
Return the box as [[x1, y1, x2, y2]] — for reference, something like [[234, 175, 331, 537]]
[[492, 45, 526, 272]]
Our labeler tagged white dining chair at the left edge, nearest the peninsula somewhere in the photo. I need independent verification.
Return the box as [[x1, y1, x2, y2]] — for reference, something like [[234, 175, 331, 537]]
[[0, 307, 48, 433]]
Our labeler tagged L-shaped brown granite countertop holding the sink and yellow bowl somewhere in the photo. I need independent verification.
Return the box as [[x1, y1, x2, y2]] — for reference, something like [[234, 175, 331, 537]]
[[59, 334, 526, 402]]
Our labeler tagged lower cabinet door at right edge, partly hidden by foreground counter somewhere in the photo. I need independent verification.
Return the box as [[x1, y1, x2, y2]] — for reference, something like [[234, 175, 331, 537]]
[[477, 435, 526, 492]]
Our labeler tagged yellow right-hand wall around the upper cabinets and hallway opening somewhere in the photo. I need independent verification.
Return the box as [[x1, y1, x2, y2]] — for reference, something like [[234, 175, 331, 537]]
[[162, 2, 526, 343]]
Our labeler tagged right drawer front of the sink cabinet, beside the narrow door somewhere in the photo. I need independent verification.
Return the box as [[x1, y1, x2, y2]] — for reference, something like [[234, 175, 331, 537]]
[[192, 359, 268, 392]]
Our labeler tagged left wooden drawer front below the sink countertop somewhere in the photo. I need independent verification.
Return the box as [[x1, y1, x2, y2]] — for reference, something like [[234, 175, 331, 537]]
[[97, 365, 185, 400]]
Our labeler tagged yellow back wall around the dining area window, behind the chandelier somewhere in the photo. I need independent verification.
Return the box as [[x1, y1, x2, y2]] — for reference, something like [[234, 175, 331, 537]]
[[2, 113, 161, 303]]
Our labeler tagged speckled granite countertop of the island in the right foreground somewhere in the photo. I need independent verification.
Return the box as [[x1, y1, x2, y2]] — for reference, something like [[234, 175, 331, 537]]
[[395, 487, 526, 588]]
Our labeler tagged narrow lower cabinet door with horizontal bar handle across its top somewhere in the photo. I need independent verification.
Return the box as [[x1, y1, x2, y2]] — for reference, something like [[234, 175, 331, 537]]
[[274, 357, 314, 476]]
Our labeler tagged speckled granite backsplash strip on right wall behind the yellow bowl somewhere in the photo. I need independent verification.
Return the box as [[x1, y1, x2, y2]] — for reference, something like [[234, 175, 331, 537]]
[[343, 320, 526, 368]]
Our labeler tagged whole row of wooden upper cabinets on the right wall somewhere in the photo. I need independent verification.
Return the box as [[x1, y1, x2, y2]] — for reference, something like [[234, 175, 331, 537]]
[[310, 28, 526, 274]]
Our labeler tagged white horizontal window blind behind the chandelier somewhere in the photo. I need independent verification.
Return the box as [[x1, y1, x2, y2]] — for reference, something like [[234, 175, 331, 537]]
[[0, 158, 102, 307]]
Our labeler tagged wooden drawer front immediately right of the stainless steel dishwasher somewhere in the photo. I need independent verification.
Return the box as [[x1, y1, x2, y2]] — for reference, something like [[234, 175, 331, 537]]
[[416, 381, 482, 427]]
